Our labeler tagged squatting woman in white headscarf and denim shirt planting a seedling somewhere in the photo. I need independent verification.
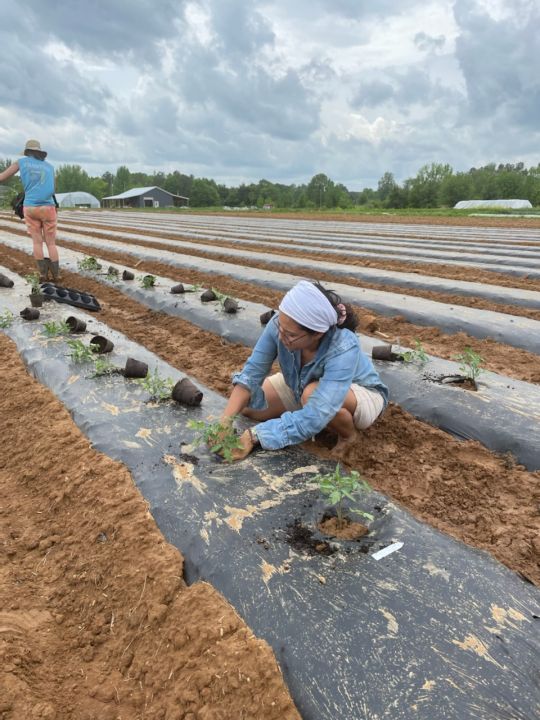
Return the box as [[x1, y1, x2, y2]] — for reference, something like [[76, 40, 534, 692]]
[[222, 280, 388, 460]]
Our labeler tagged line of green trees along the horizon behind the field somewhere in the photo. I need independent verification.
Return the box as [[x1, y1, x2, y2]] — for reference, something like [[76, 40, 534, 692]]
[[0, 159, 540, 210]]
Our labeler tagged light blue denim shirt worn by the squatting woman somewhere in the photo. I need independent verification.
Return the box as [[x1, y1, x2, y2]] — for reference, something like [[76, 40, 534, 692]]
[[232, 315, 388, 450]]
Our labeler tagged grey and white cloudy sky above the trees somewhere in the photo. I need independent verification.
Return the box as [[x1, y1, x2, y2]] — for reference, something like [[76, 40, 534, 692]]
[[0, 0, 540, 190]]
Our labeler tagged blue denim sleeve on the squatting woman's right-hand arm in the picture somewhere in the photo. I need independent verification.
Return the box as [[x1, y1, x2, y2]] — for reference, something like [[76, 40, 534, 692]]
[[257, 348, 356, 450]]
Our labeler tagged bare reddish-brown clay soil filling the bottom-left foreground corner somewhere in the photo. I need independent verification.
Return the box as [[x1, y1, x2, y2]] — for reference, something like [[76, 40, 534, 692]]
[[0, 334, 300, 720]]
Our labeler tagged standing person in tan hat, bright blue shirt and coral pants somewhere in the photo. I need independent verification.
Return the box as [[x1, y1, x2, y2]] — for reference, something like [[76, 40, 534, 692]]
[[0, 140, 60, 282]]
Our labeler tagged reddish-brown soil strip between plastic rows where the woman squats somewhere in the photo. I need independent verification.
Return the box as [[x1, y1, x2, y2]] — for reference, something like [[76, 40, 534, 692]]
[[0, 246, 540, 583]]
